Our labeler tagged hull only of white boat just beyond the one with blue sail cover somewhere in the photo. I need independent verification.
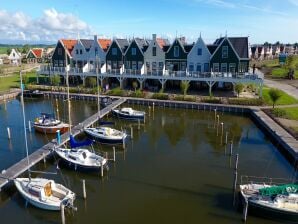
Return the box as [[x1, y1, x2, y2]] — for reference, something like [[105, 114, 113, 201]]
[[84, 126, 127, 144]]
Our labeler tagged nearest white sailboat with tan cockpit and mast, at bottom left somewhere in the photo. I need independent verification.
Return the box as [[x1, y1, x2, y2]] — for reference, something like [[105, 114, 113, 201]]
[[14, 72, 75, 211]]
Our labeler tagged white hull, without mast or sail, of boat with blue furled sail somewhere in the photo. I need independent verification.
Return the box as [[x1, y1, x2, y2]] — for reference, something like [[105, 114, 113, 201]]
[[54, 147, 108, 171]]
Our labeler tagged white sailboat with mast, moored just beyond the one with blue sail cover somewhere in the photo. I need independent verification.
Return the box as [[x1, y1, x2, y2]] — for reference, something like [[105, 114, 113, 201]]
[[84, 56, 127, 144]]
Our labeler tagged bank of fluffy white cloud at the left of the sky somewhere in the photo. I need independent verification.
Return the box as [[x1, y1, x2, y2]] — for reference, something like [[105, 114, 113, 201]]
[[0, 8, 91, 41]]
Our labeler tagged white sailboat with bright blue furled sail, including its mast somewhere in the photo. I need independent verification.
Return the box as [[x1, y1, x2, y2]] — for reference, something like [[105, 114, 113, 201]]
[[54, 55, 107, 170]]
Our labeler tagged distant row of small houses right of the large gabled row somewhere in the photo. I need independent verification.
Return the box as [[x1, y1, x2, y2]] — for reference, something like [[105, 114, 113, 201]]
[[249, 44, 298, 60]]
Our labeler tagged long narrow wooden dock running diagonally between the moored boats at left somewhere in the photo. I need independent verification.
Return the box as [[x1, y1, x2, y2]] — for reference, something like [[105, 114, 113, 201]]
[[0, 98, 126, 191]]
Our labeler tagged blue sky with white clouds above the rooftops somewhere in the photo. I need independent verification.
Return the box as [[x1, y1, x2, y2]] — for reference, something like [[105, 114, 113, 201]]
[[0, 0, 298, 44]]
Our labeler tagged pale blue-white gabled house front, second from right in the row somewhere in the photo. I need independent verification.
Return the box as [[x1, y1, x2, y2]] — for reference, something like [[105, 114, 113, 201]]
[[187, 37, 211, 72]]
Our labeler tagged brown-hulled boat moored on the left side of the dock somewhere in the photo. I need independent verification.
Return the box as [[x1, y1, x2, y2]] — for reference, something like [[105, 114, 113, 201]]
[[34, 113, 69, 134]]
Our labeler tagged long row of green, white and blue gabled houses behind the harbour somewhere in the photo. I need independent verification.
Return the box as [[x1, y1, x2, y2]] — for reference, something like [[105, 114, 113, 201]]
[[51, 34, 249, 75]]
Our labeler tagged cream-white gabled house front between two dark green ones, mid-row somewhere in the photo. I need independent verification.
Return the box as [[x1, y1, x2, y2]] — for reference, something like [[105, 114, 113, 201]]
[[144, 34, 166, 73]]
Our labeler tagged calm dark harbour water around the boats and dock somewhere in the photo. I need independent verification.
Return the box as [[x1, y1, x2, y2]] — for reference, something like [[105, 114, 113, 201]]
[[0, 97, 293, 224]]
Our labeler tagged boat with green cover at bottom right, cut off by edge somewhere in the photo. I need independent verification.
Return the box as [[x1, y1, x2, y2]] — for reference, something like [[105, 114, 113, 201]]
[[240, 183, 298, 222]]
